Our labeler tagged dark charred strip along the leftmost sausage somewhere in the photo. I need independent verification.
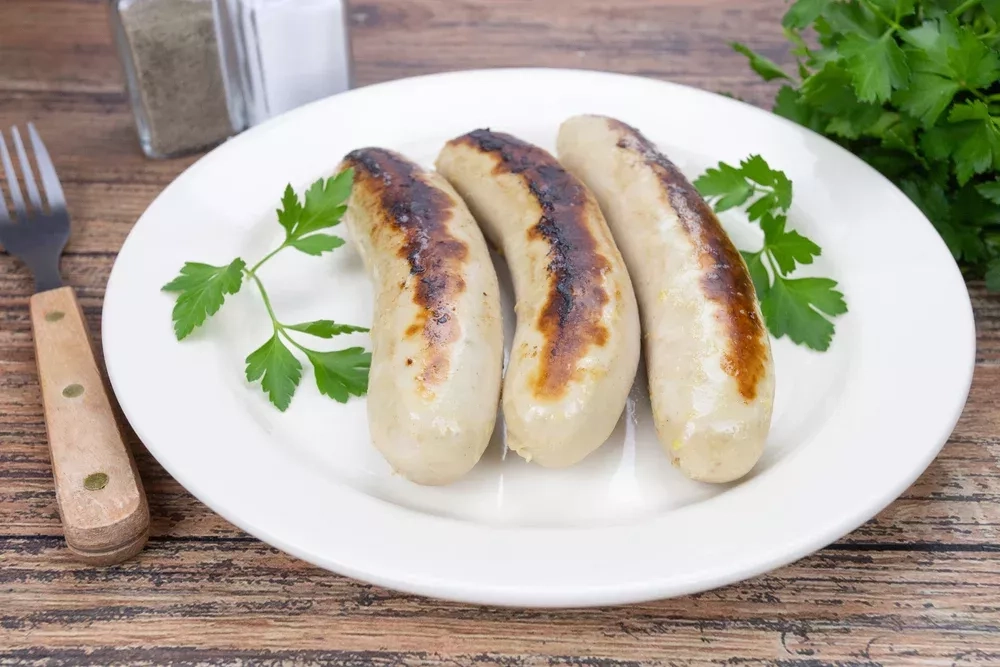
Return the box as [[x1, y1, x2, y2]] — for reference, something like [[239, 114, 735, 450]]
[[344, 148, 469, 385]]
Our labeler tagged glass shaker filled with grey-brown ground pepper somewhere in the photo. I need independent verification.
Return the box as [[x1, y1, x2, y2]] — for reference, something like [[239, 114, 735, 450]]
[[112, 0, 245, 157]]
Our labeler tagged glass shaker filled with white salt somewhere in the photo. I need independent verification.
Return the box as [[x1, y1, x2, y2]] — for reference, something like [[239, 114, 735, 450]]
[[216, 0, 352, 125]]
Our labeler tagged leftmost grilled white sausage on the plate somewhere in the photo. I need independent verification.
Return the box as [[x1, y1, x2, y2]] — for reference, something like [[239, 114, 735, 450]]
[[341, 148, 503, 484]]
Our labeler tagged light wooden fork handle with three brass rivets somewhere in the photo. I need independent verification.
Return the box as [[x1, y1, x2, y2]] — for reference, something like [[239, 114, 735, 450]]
[[31, 287, 149, 565]]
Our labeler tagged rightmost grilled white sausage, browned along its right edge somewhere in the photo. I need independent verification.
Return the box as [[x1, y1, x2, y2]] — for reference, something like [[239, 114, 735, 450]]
[[558, 116, 774, 482]]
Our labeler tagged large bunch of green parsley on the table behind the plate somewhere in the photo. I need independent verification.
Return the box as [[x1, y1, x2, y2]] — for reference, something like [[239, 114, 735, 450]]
[[733, 0, 1000, 290]]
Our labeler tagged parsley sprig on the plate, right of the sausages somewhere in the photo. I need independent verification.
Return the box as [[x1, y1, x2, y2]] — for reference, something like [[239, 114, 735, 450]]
[[694, 155, 847, 351]]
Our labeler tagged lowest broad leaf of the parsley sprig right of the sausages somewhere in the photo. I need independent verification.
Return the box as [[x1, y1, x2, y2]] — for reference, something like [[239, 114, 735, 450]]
[[760, 276, 847, 352]]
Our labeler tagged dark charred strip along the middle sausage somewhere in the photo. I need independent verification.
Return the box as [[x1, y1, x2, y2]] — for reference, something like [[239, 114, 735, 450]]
[[453, 130, 611, 399]]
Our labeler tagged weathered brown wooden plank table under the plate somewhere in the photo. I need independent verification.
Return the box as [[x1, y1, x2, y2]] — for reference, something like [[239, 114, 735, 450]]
[[0, 0, 1000, 667]]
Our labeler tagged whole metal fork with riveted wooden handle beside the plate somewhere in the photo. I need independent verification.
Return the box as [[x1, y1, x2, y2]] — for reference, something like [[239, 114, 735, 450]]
[[0, 123, 149, 564]]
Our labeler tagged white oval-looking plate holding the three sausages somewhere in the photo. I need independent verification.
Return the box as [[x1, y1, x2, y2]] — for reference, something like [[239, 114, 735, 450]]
[[103, 70, 975, 606]]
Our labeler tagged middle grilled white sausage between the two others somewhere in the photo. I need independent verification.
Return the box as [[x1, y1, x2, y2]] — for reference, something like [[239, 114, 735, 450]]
[[437, 130, 639, 467]]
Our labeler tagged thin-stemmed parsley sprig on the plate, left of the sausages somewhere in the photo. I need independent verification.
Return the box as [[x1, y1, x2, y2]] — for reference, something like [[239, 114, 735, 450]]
[[163, 169, 371, 411]]
